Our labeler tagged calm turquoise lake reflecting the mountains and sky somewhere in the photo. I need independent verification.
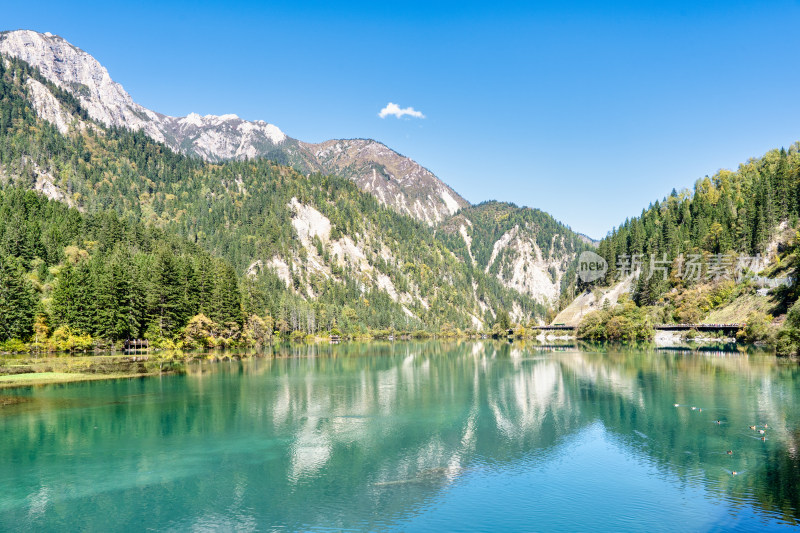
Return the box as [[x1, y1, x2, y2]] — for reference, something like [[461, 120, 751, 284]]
[[0, 342, 800, 531]]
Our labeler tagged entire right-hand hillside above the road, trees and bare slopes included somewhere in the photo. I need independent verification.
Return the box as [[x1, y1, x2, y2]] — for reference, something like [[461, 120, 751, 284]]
[[556, 143, 800, 354]]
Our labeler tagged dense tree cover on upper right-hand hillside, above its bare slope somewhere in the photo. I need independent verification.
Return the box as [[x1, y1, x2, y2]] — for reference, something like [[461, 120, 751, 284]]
[[598, 143, 800, 303]]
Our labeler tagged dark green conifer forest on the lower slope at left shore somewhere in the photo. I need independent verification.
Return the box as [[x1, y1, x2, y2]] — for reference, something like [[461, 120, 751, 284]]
[[0, 188, 252, 342]]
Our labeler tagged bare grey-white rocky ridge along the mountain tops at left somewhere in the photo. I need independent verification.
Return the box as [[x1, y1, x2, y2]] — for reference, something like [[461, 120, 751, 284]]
[[0, 30, 469, 224]]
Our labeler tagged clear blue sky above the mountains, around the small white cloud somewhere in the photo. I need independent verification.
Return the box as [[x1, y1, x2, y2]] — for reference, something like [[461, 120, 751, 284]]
[[2, 0, 800, 237]]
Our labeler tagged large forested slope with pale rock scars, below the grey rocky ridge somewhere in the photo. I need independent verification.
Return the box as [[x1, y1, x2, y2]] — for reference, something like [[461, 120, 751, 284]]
[[0, 54, 563, 338]]
